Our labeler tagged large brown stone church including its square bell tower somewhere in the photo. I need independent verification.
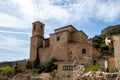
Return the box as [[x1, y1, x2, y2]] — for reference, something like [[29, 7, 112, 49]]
[[30, 21, 100, 65]]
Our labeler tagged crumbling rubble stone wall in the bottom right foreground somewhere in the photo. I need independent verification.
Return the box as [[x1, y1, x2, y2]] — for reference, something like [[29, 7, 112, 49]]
[[73, 61, 120, 80]]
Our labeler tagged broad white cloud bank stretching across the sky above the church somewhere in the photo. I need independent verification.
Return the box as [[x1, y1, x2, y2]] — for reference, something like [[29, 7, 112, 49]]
[[0, 0, 120, 29]]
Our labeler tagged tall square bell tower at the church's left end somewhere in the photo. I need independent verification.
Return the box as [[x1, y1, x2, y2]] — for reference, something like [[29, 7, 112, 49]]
[[30, 21, 45, 61]]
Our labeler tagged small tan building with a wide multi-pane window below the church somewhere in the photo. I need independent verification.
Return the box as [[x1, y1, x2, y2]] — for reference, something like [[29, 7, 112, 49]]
[[55, 62, 73, 80]]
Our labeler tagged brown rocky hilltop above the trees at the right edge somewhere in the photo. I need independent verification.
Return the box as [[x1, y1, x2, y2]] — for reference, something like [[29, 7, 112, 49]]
[[101, 24, 120, 35]]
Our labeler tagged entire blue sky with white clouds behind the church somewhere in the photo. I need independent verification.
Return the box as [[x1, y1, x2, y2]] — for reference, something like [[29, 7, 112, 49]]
[[0, 0, 120, 62]]
